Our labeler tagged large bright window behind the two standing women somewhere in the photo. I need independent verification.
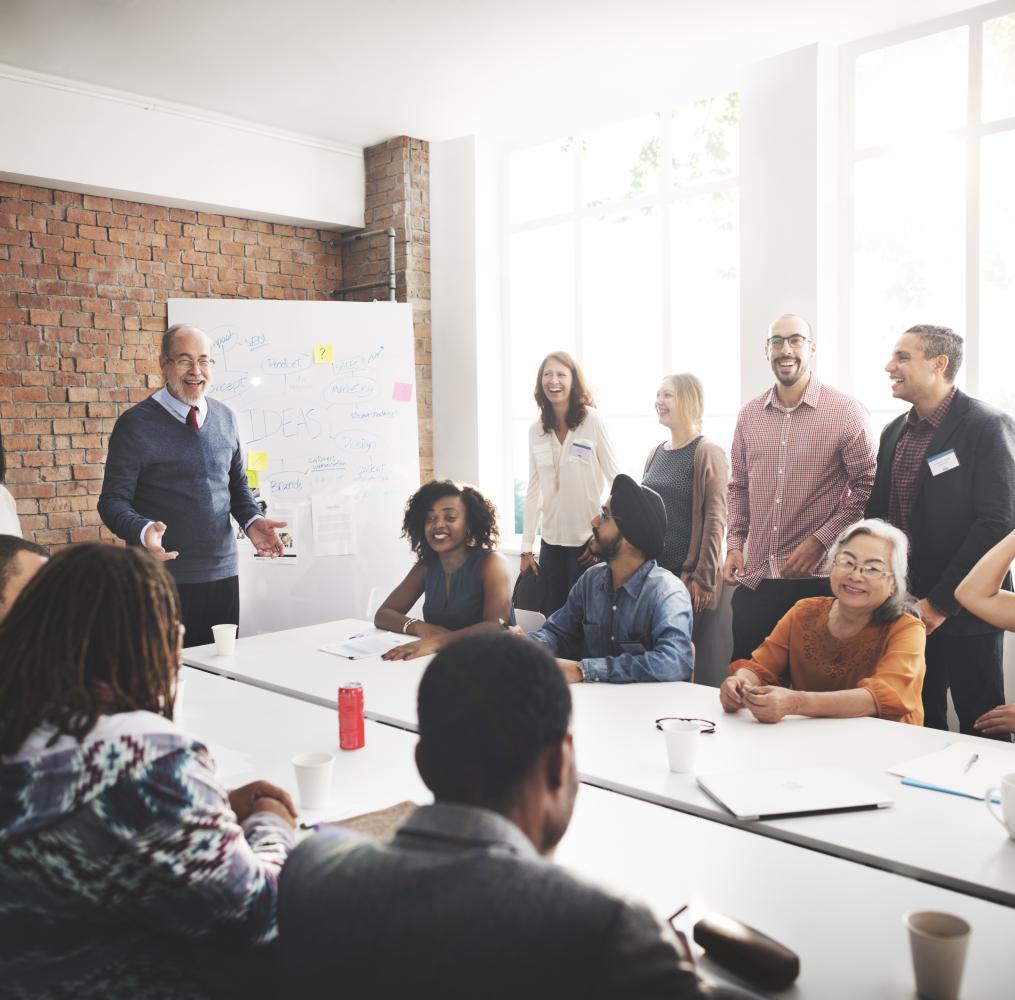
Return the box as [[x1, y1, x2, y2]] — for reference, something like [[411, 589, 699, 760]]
[[500, 92, 740, 532]]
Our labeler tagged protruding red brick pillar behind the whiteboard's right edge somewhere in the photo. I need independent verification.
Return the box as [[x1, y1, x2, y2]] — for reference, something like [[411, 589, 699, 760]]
[[342, 135, 433, 482]]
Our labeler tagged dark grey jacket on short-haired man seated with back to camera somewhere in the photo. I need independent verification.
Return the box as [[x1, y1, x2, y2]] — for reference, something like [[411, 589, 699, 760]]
[[279, 803, 704, 1000]]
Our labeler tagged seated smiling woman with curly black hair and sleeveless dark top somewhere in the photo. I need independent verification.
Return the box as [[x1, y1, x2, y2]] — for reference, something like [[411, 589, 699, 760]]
[[374, 479, 514, 660]]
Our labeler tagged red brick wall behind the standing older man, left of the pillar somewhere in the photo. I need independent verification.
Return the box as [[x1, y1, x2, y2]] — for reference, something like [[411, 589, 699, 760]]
[[0, 183, 343, 547]]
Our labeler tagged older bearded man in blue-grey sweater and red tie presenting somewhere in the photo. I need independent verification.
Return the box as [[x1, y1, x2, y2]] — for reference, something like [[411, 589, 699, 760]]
[[98, 324, 284, 646]]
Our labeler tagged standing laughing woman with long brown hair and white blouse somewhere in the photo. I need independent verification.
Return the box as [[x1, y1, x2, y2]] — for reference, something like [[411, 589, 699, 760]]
[[521, 351, 620, 617]]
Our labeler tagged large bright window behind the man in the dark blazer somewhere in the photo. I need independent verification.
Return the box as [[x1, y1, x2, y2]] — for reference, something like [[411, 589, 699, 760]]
[[841, 4, 1015, 427]]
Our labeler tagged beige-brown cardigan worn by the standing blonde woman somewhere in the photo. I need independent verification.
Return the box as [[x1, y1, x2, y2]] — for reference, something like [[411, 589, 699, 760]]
[[642, 438, 730, 611]]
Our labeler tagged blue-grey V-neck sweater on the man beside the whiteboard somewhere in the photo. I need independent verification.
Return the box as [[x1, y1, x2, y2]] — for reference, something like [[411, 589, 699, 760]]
[[98, 397, 261, 584]]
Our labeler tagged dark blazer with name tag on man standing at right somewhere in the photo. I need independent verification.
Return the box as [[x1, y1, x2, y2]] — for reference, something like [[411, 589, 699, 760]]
[[867, 390, 1015, 636]]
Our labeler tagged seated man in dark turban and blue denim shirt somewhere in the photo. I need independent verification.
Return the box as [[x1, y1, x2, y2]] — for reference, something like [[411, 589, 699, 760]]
[[529, 473, 694, 684]]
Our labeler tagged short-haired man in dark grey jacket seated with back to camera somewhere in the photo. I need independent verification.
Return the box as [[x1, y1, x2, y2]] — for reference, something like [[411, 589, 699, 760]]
[[279, 632, 712, 1000]]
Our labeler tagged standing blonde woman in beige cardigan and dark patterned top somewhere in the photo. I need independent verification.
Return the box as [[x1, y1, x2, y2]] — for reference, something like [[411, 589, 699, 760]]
[[641, 374, 729, 614]]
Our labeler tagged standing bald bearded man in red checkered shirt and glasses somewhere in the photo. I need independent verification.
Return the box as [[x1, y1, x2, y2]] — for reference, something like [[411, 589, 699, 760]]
[[723, 314, 877, 660]]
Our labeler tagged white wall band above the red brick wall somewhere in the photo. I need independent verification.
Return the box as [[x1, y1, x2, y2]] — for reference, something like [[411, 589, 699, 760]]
[[0, 66, 365, 228]]
